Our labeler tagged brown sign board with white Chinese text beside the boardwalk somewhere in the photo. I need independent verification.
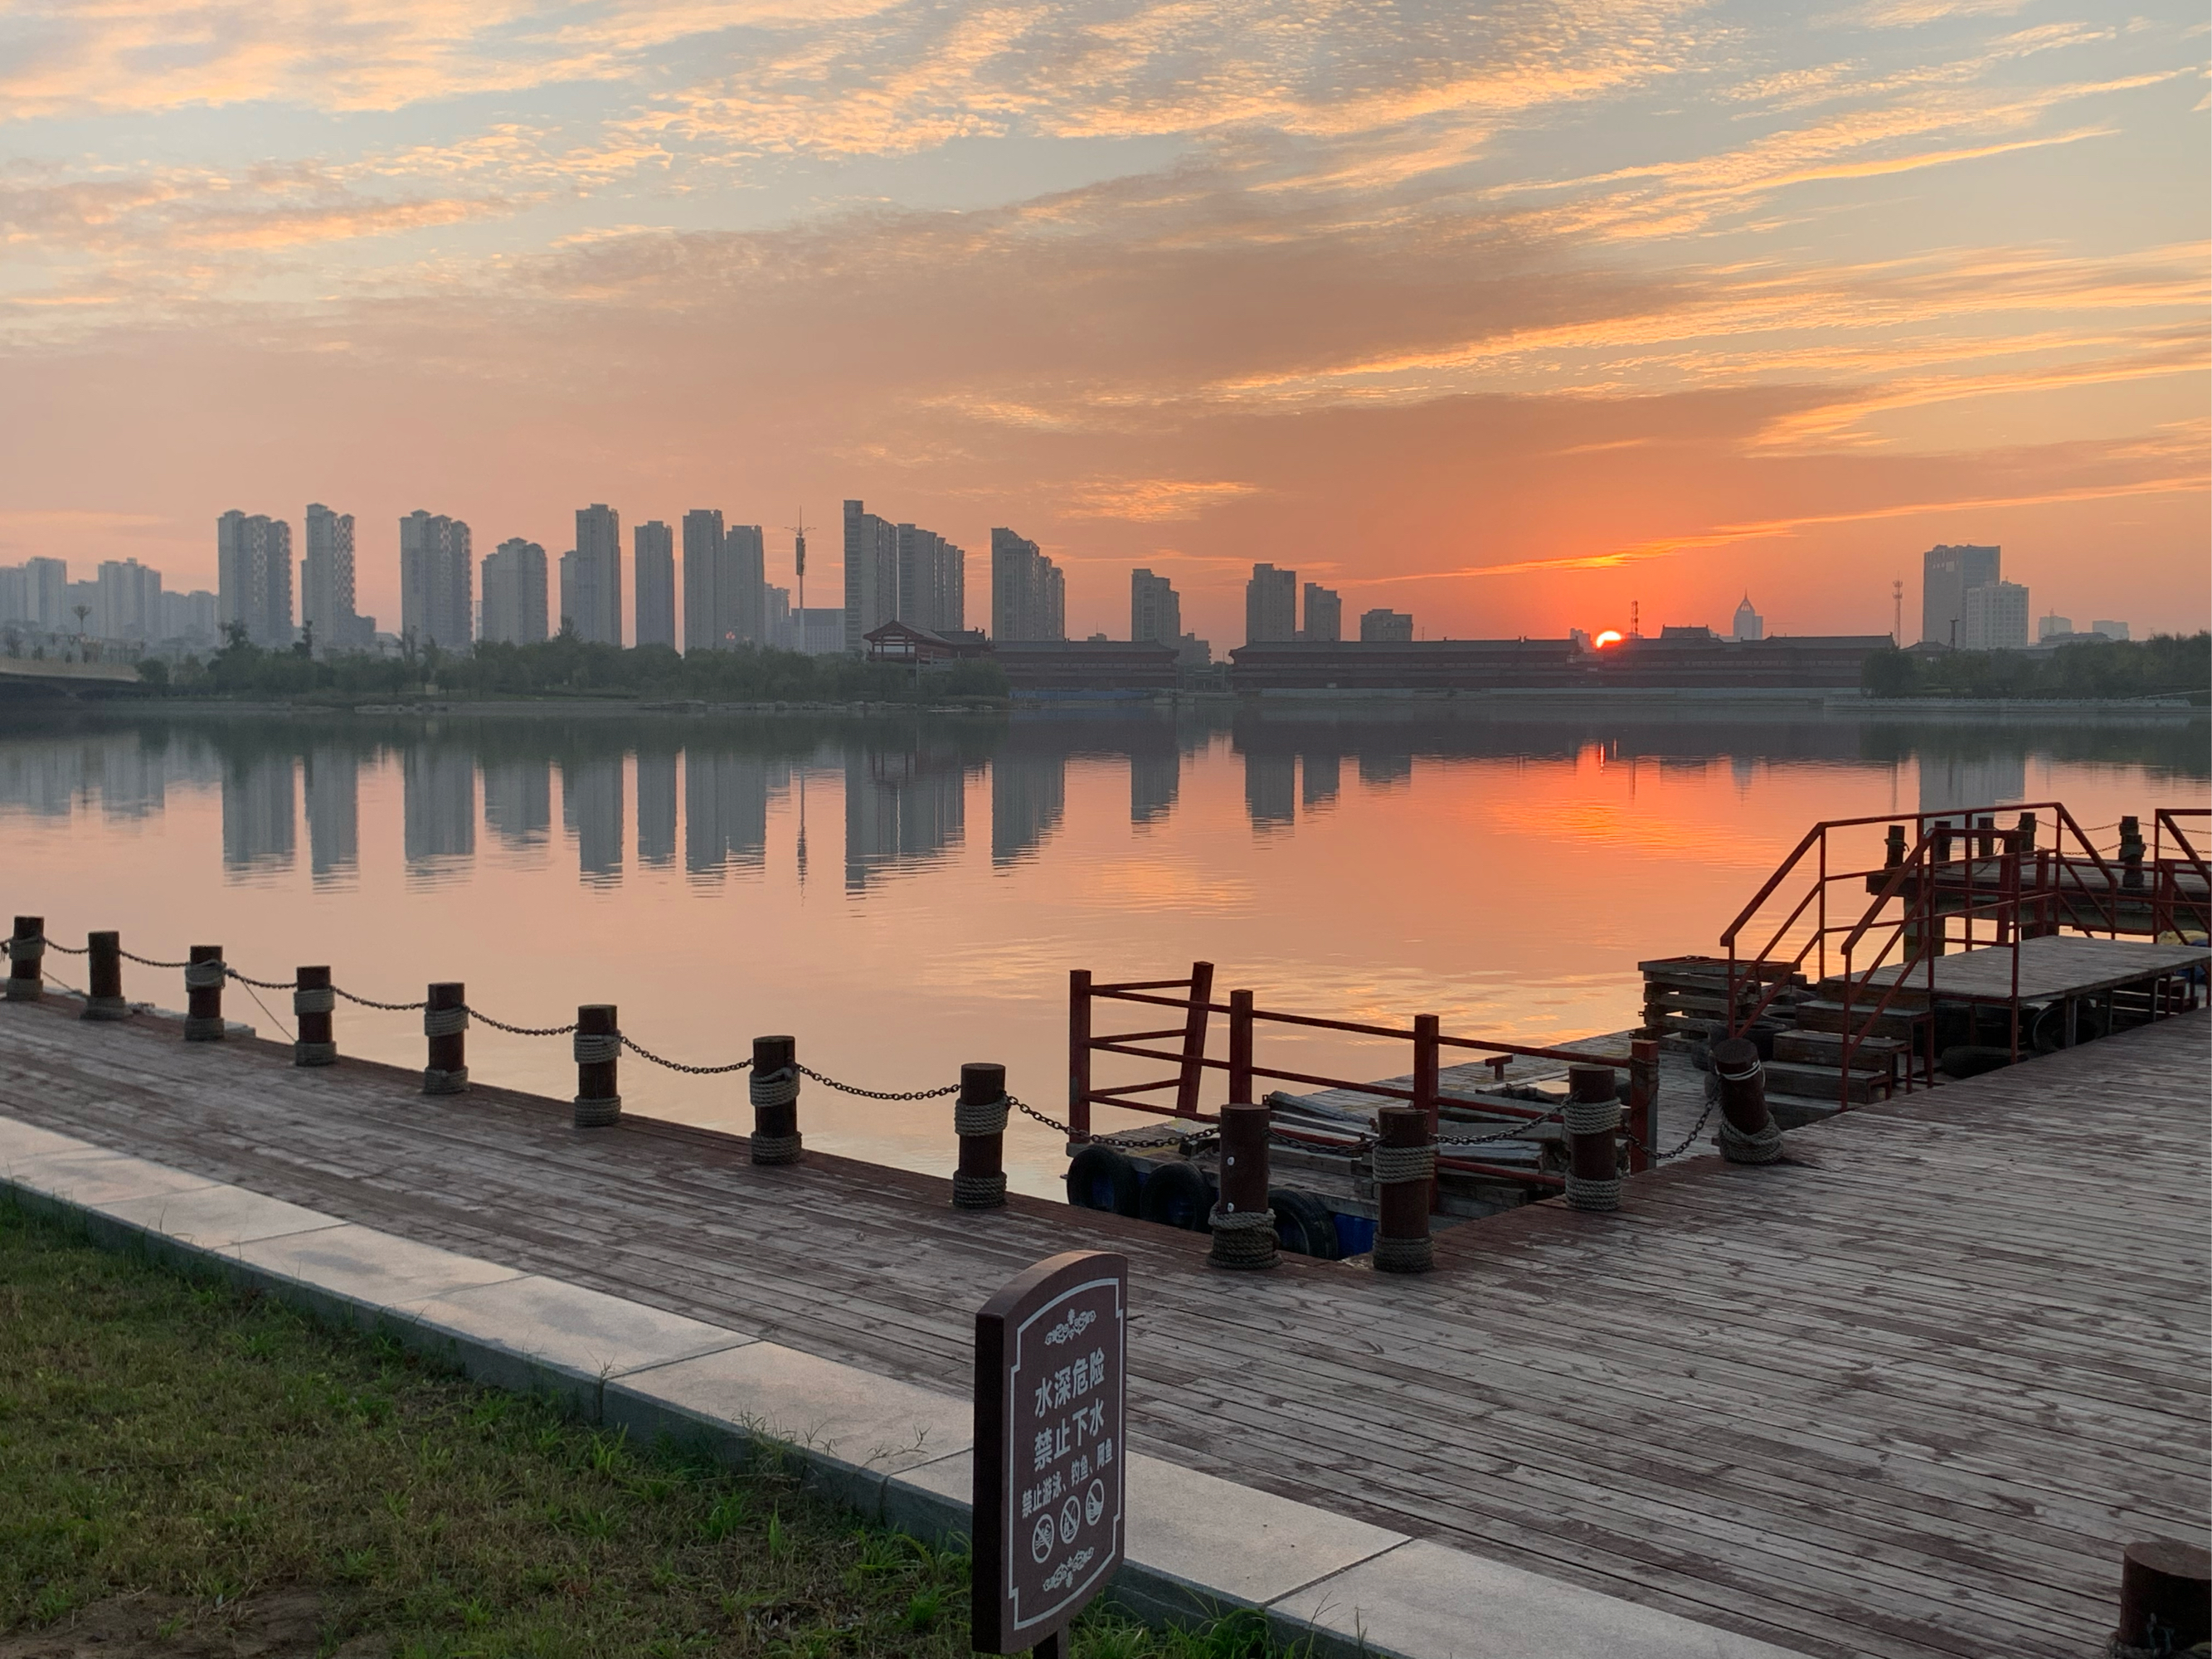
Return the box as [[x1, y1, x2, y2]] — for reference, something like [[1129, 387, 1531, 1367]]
[[971, 1250, 1128, 1652]]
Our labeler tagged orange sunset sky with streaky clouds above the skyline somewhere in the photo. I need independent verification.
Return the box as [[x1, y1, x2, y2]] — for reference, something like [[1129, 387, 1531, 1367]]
[[0, 0, 2212, 650]]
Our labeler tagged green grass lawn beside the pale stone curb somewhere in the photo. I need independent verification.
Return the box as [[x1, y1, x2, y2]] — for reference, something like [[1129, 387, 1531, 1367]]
[[0, 1201, 1300, 1659]]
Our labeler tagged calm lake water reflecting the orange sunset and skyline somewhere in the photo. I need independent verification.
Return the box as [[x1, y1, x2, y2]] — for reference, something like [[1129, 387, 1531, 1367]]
[[0, 710, 2212, 1192]]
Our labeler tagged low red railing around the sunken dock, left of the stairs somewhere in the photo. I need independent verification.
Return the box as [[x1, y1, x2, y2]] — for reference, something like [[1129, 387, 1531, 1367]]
[[1068, 962, 1659, 1185]]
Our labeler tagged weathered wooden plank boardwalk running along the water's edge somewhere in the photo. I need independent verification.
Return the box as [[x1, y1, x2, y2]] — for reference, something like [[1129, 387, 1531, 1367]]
[[0, 1000, 2212, 1659]]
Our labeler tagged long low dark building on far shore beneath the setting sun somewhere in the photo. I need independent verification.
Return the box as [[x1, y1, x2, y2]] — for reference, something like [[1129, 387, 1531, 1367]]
[[1230, 635, 1889, 693]]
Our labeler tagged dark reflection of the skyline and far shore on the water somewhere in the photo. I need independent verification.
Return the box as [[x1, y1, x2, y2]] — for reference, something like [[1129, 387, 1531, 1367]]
[[0, 710, 2212, 896]]
